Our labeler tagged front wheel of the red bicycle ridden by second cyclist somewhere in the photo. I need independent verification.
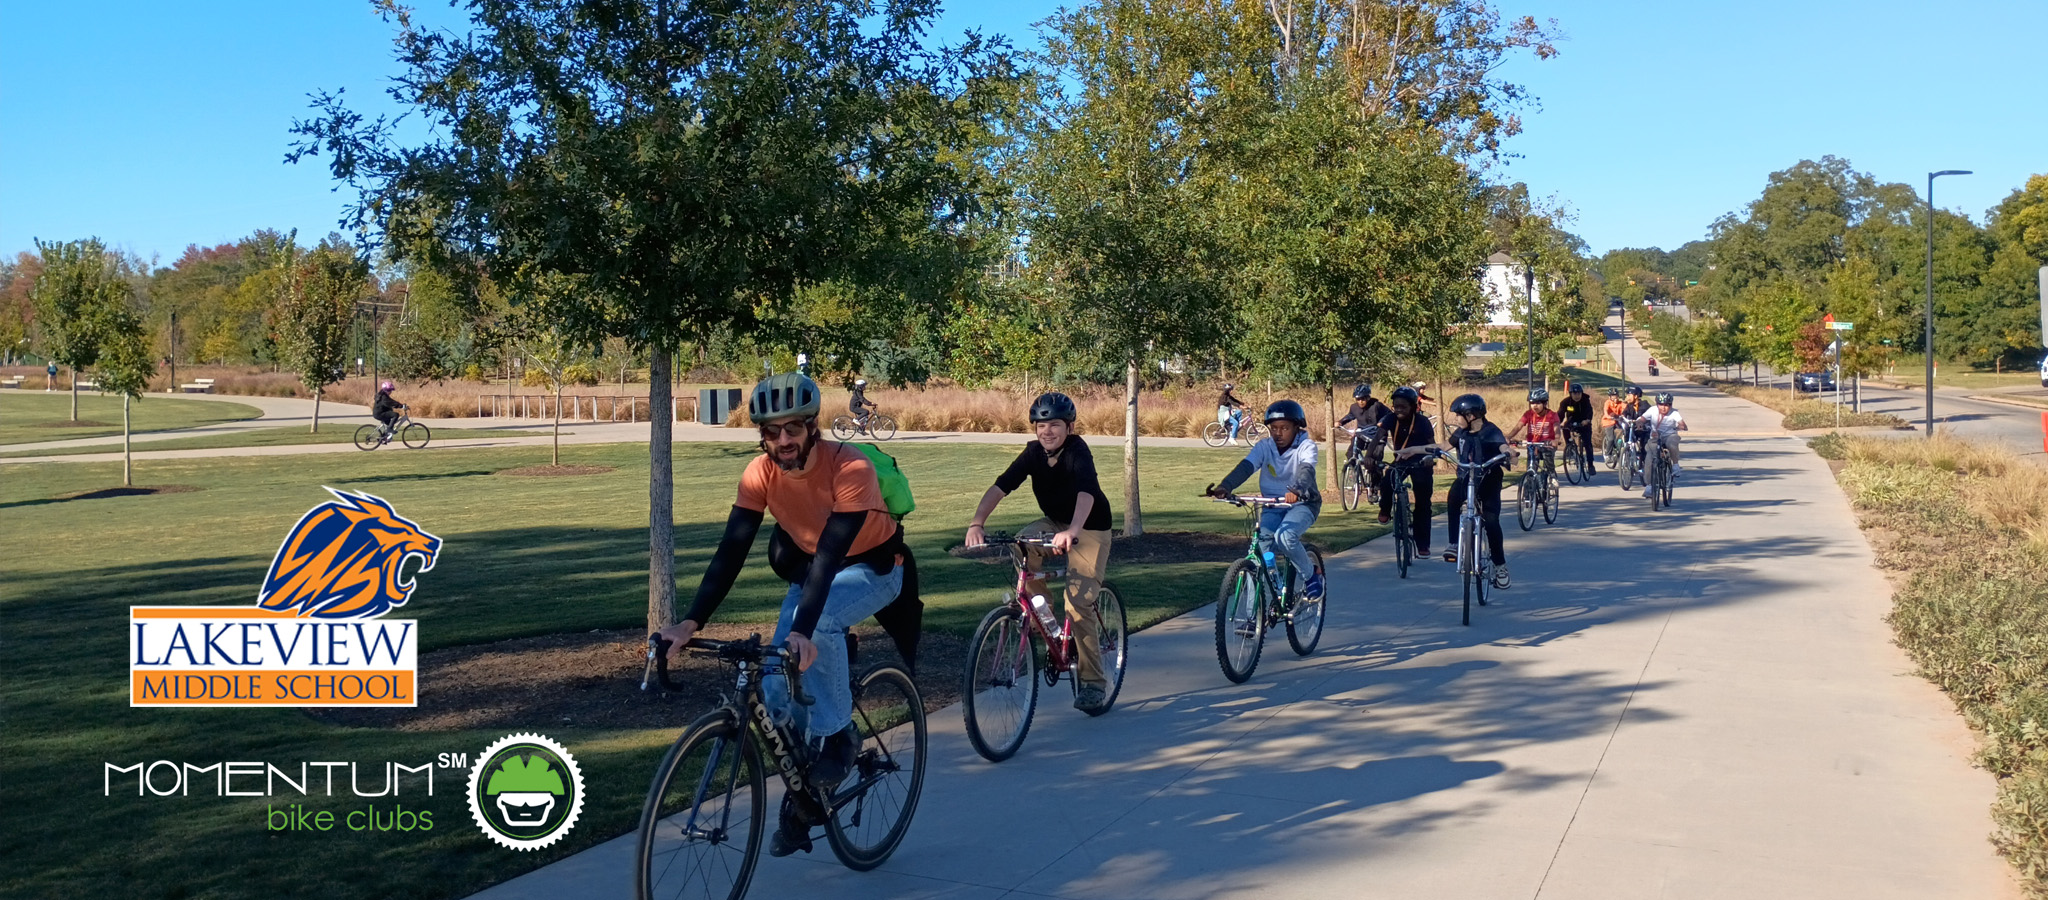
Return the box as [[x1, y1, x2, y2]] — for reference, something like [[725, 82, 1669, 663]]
[[961, 603, 1038, 763]]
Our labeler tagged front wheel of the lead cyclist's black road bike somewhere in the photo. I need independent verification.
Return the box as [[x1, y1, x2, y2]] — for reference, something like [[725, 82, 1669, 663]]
[[633, 709, 768, 900]]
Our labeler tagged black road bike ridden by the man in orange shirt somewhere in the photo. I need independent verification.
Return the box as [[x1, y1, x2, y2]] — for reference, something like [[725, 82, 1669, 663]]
[[633, 633, 926, 900]]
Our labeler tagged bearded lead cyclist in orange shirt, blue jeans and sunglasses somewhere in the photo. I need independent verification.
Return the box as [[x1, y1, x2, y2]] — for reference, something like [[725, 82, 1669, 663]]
[[659, 371, 922, 857]]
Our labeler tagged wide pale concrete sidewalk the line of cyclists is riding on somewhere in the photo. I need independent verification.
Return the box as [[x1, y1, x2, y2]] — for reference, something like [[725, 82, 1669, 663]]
[[464, 371, 2019, 900]]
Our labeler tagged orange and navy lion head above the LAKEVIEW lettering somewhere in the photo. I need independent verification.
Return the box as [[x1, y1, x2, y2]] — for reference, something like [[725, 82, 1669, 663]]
[[256, 488, 440, 619]]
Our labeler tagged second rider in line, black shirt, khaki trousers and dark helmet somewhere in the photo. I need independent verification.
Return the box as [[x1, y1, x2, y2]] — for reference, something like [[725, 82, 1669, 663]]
[[967, 394, 1110, 711]]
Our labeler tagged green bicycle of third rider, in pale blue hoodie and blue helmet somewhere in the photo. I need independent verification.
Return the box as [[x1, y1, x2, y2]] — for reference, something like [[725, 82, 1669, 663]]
[[1212, 494, 1327, 685]]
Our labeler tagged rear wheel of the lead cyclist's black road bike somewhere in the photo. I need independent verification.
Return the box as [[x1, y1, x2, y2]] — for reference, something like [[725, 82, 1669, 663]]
[[825, 662, 930, 871]]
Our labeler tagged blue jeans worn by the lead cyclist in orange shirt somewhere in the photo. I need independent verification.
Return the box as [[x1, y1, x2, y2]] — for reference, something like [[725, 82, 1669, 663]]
[[762, 564, 903, 738]]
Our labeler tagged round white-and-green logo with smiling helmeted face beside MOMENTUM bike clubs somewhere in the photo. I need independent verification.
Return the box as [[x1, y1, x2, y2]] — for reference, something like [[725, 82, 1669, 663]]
[[469, 732, 584, 851]]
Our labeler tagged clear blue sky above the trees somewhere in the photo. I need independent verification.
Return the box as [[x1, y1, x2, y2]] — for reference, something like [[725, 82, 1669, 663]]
[[0, 0, 2048, 264]]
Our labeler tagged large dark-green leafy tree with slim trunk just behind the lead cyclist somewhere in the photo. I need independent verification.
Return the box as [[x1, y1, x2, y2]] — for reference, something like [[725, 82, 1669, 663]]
[[293, 0, 1014, 625]]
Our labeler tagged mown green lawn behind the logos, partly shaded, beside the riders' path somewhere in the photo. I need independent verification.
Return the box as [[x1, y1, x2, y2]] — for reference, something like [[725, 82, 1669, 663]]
[[0, 438, 1442, 900]]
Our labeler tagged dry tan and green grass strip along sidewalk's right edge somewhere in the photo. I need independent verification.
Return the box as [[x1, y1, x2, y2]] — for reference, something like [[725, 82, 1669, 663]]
[[1812, 435, 2048, 898]]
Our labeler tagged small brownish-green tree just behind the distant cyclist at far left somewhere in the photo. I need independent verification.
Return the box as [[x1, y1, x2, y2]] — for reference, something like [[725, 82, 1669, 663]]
[[272, 244, 371, 433]]
